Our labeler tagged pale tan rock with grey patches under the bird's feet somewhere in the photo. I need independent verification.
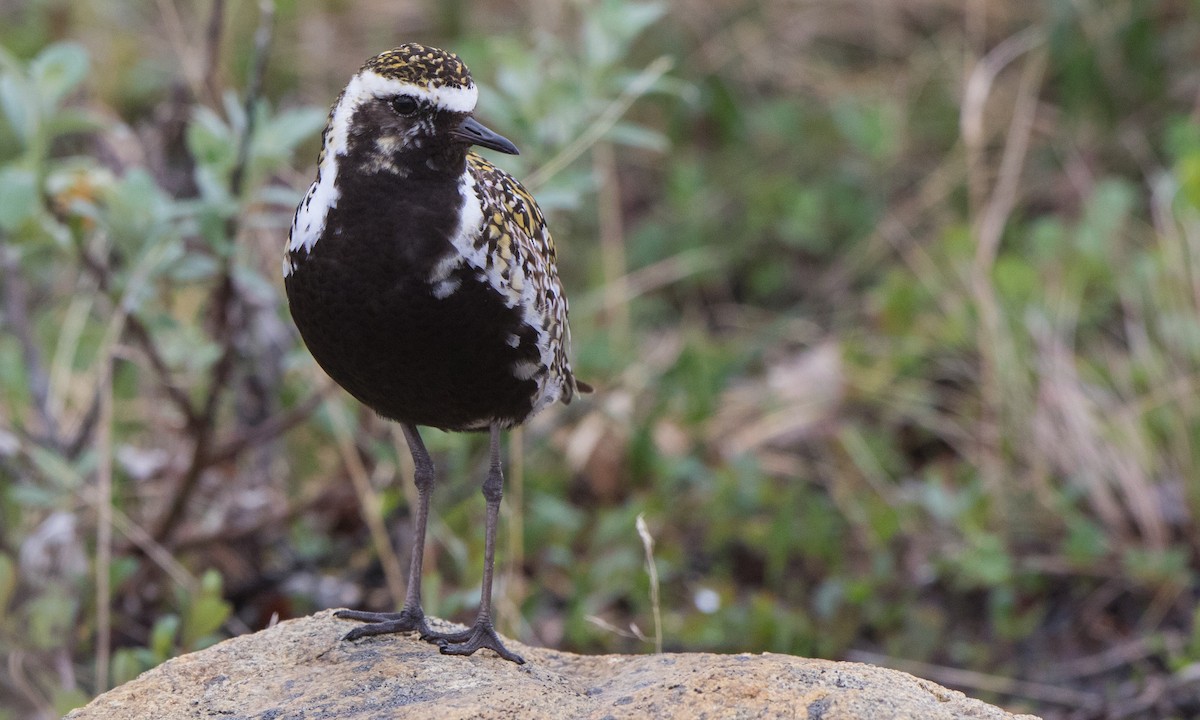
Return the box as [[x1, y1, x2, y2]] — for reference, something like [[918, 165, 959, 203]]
[[67, 611, 1032, 720]]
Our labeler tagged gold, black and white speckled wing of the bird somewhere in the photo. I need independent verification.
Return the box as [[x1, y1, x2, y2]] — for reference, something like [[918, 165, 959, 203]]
[[467, 152, 587, 404]]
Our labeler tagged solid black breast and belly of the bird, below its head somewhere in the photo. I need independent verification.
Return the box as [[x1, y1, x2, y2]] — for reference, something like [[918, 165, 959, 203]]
[[284, 175, 539, 430]]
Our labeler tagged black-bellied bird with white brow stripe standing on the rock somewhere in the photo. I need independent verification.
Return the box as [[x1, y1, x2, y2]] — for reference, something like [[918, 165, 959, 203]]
[[283, 43, 592, 664]]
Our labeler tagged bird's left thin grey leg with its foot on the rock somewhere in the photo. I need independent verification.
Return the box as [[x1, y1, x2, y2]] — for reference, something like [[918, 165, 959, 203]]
[[334, 422, 433, 640]]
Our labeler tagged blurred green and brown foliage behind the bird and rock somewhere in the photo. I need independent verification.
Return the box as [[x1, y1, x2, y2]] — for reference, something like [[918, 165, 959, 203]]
[[0, 0, 1200, 719]]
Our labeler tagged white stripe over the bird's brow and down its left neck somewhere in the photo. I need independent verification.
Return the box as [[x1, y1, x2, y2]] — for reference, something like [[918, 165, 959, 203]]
[[283, 71, 482, 277]]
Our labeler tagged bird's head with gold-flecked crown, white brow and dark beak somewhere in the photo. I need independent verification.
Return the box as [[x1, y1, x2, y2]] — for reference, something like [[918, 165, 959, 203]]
[[324, 43, 517, 174]]
